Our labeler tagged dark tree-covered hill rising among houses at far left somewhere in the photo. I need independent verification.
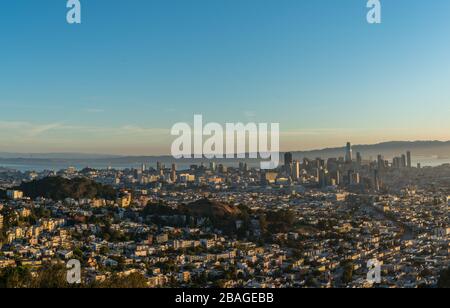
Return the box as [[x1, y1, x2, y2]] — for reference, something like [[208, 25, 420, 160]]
[[17, 177, 116, 200]]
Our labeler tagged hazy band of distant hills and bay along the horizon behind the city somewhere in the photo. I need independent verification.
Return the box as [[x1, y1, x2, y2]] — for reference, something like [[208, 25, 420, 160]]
[[0, 141, 450, 169]]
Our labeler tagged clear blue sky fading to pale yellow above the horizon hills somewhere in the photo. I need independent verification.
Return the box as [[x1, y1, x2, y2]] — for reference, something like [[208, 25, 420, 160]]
[[0, 0, 450, 155]]
